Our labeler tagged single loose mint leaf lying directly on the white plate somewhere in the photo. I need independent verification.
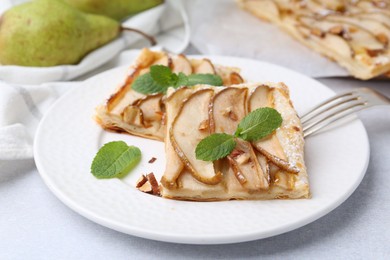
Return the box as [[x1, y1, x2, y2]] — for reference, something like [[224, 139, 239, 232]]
[[91, 141, 141, 179]]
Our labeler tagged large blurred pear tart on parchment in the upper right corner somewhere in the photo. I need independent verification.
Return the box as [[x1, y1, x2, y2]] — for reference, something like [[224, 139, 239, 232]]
[[237, 0, 390, 79]]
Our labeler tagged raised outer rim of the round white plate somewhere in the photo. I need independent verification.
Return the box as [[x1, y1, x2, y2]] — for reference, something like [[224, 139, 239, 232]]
[[34, 55, 370, 244]]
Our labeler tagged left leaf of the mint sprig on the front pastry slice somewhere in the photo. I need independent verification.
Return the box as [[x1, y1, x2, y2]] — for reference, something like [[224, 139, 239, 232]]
[[195, 133, 236, 161]]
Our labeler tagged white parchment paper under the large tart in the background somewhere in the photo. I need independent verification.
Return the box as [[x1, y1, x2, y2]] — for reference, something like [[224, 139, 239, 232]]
[[185, 0, 349, 77]]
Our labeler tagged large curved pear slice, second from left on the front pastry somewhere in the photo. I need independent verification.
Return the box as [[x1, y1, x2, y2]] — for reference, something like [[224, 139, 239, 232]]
[[169, 89, 222, 185]]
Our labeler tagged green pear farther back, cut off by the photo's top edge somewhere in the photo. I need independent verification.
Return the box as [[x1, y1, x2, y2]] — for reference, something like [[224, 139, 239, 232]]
[[65, 0, 164, 21]]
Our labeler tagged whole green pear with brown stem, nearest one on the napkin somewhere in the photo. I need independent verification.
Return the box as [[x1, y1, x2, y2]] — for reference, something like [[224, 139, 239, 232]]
[[0, 0, 121, 67]]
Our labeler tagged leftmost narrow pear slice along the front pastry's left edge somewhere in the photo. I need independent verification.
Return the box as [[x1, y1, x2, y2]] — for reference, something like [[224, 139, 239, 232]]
[[161, 88, 192, 189]]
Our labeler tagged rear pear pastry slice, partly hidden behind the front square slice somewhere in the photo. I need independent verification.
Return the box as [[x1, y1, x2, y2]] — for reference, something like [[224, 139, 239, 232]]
[[95, 49, 243, 141]]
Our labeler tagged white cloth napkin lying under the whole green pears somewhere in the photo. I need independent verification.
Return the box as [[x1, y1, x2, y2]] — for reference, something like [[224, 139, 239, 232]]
[[0, 0, 189, 162]]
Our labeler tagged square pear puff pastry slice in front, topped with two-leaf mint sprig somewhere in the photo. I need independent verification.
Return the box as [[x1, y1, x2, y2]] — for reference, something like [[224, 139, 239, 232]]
[[161, 83, 310, 201]]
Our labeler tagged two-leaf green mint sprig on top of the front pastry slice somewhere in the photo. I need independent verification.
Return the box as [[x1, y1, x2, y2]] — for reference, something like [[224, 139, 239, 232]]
[[195, 107, 283, 161]]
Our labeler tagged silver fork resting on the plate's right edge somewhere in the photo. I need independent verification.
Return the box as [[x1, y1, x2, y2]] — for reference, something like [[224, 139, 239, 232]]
[[301, 88, 390, 137]]
